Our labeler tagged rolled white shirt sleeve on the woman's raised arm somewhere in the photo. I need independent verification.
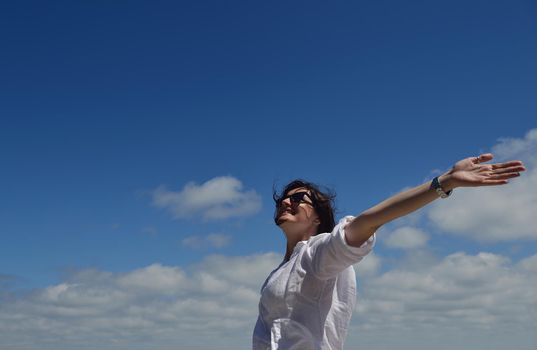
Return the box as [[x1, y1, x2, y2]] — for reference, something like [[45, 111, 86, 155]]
[[301, 216, 376, 280]]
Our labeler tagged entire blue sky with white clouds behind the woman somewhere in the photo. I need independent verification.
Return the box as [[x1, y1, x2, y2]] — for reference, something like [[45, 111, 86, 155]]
[[0, 0, 537, 350]]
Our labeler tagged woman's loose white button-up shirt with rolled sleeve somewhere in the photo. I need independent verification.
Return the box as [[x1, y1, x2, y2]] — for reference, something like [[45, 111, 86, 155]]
[[253, 216, 375, 350]]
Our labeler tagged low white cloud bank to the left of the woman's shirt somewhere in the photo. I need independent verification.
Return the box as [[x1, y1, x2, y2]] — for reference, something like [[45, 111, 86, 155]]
[[0, 253, 281, 350]]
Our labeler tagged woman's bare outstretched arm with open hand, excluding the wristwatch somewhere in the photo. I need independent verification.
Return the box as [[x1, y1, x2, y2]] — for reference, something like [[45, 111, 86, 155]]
[[345, 153, 526, 247]]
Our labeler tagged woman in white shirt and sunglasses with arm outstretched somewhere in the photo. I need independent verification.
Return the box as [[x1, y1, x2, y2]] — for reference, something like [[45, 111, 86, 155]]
[[253, 153, 525, 350]]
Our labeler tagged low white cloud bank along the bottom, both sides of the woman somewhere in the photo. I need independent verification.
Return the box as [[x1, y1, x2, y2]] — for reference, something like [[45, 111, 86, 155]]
[[0, 253, 537, 350]]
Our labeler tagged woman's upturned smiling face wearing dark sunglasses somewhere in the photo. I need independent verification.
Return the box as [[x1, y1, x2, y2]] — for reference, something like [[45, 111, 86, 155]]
[[277, 187, 320, 234]]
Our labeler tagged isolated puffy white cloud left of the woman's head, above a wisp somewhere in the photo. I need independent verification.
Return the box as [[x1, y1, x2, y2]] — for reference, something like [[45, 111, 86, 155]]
[[152, 176, 261, 220]]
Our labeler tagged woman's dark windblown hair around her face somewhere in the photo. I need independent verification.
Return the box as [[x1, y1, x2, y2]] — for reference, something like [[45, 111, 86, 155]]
[[272, 179, 336, 235]]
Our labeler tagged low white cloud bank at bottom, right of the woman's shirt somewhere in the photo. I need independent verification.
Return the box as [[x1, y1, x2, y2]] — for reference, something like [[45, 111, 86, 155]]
[[348, 253, 537, 350]]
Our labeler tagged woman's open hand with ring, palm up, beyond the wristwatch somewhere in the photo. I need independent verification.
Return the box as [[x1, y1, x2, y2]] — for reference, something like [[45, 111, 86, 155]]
[[448, 153, 526, 187]]
